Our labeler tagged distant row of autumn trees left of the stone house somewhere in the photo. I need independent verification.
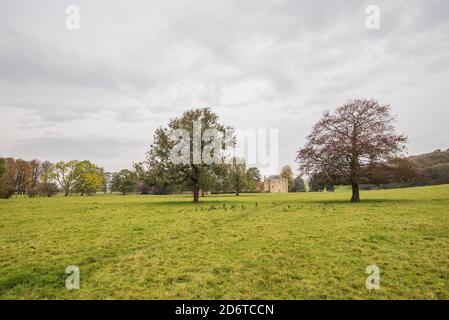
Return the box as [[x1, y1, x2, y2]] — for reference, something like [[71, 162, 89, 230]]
[[0, 158, 270, 198]]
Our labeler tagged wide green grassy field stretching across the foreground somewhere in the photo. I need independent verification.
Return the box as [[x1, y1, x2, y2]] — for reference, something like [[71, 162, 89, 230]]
[[0, 185, 449, 299]]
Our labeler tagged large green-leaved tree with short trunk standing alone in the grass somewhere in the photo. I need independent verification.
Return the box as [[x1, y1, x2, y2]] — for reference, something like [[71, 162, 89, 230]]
[[147, 108, 232, 203]]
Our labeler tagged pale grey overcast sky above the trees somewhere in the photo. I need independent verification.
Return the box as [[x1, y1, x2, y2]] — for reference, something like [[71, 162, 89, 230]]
[[0, 0, 449, 174]]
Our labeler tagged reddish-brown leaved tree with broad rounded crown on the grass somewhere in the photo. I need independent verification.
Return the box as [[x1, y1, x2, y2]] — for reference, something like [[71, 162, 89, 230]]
[[297, 99, 407, 202]]
